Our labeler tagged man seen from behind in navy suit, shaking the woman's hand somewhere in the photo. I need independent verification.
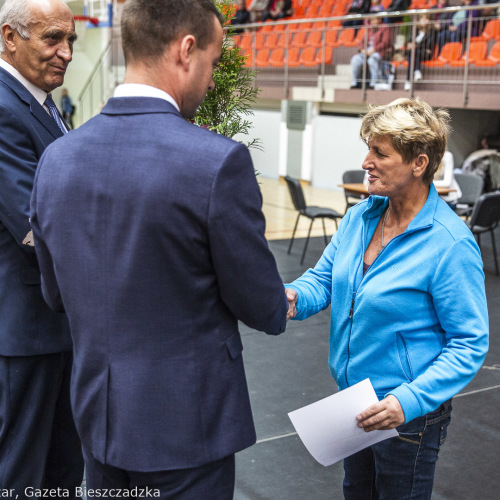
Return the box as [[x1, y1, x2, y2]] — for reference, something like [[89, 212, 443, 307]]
[[31, 0, 288, 500]]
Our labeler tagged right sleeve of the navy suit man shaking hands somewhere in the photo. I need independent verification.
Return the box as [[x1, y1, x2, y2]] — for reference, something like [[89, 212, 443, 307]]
[[208, 144, 288, 335]]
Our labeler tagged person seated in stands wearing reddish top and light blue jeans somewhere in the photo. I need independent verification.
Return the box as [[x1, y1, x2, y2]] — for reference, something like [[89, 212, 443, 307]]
[[351, 17, 392, 89]]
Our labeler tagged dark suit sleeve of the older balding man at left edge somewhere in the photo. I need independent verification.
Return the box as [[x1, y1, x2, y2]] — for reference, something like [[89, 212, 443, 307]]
[[0, 102, 38, 253]]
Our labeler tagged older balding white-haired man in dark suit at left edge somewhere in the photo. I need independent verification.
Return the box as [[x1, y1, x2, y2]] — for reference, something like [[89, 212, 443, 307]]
[[0, 0, 83, 498]]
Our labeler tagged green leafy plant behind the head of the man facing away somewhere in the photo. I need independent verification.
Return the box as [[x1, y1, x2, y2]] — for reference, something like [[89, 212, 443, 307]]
[[194, 0, 260, 148]]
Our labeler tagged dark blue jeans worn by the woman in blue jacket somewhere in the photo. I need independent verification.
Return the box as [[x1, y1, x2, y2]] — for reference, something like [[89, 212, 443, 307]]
[[344, 400, 452, 500]]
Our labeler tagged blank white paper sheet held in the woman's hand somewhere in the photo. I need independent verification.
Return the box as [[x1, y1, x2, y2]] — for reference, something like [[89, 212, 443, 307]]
[[288, 379, 398, 466]]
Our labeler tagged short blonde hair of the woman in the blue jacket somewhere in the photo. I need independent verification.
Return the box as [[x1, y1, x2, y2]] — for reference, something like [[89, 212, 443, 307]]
[[360, 98, 451, 184]]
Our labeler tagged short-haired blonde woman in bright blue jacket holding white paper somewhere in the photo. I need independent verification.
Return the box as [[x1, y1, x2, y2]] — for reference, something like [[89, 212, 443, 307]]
[[287, 99, 488, 500]]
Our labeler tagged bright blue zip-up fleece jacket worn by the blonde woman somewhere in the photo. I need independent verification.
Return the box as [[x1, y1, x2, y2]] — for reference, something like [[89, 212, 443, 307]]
[[286, 186, 489, 422]]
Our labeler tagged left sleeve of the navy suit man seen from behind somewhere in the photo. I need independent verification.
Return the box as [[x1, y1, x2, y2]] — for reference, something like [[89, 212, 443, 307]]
[[31, 149, 65, 312]]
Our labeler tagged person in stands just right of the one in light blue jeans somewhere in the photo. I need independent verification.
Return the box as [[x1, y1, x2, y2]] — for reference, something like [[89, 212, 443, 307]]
[[404, 14, 437, 90]]
